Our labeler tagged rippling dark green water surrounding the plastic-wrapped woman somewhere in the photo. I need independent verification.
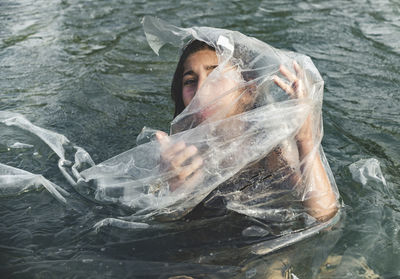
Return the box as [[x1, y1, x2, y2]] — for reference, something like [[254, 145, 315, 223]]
[[0, 0, 400, 278]]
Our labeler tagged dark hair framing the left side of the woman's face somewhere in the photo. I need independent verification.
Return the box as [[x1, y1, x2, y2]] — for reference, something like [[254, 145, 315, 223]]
[[171, 40, 215, 118]]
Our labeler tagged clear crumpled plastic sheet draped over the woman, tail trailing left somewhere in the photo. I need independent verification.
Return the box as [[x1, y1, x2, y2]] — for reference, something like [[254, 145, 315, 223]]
[[0, 17, 339, 254]]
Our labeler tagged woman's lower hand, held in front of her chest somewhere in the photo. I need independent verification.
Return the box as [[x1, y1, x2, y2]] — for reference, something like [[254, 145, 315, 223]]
[[156, 131, 203, 191]]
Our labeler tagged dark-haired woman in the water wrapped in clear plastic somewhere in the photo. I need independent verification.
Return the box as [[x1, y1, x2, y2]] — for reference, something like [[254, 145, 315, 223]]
[[156, 40, 337, 221]]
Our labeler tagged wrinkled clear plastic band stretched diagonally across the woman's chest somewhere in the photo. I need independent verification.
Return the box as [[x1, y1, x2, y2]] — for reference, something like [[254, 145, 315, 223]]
[[82, 99, 307, 218]]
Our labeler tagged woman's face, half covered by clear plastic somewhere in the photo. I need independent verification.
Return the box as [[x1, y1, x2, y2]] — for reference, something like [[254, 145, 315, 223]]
[[182, 49, 241, 120]]
